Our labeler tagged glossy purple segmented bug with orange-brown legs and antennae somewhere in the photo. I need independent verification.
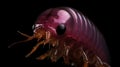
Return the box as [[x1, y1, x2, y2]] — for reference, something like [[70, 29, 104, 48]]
[[9, 7, 110, 67]]
